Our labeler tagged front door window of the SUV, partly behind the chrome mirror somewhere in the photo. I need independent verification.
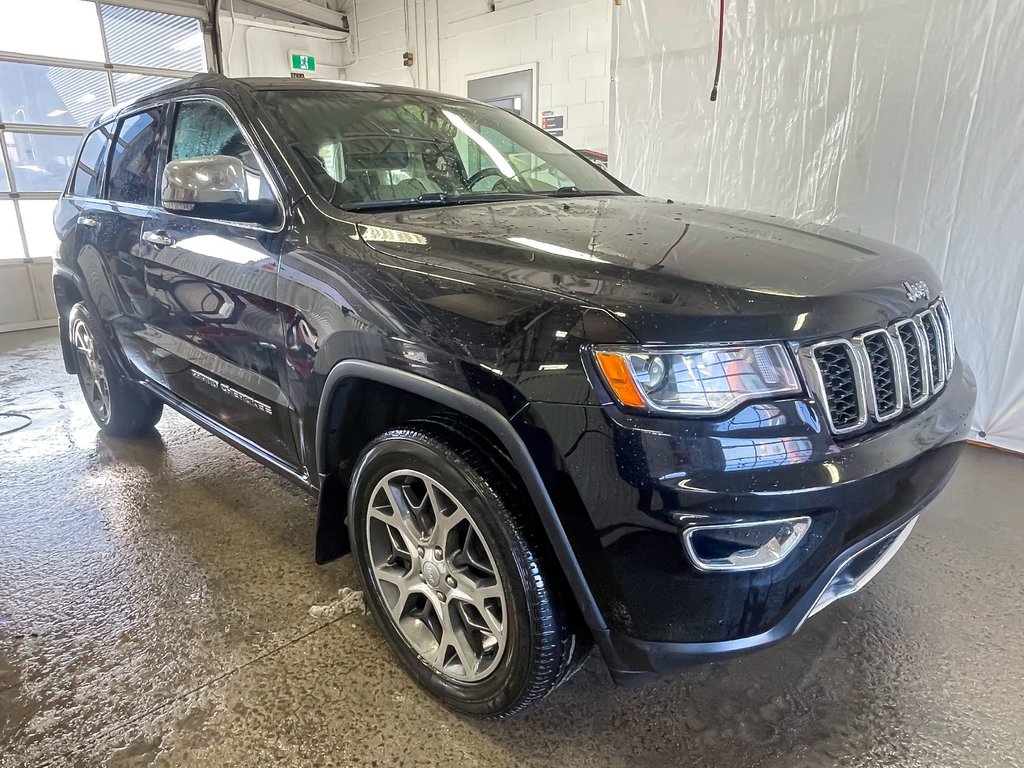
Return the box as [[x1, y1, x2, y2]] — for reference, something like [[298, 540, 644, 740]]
[[171, 100, 274, 202]]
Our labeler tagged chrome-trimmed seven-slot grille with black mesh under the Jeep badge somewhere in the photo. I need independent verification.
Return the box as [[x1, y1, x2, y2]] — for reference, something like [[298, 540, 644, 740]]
[[800, 296, 954, 434]]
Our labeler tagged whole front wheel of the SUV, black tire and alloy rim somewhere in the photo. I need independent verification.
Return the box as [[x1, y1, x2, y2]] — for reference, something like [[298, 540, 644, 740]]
[[348, 425, 589, 718]]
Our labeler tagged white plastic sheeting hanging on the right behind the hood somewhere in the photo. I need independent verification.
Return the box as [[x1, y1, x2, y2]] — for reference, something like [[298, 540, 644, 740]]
[[611, 0, 1024, 452]]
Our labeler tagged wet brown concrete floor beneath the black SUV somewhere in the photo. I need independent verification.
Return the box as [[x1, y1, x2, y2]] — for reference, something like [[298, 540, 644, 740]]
[[0, 331, 1024, 768]]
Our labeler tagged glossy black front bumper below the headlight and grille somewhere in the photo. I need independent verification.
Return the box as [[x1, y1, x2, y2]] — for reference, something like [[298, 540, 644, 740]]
[[515, 362, 975, 679]]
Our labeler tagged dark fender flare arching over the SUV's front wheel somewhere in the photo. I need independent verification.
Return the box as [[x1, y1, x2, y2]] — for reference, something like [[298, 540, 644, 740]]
[[316, 359, 608, 643]]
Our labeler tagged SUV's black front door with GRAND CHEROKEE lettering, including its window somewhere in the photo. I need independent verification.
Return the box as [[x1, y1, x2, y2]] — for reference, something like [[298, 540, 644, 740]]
[[141, 95, 299, 468]]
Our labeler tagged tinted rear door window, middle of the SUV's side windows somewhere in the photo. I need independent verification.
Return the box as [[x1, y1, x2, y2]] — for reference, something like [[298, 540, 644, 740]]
[[106, 109, 161, 206]]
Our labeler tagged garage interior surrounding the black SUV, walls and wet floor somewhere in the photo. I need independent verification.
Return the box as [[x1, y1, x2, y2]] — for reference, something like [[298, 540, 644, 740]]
[[0, 0, 1024, 768]]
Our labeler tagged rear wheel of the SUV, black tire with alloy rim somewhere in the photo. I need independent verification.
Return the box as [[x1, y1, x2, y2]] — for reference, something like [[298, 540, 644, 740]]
[[68, 302, 164, 437]]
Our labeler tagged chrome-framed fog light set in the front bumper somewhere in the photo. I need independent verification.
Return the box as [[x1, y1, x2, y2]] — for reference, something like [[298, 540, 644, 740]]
[[683, 517, 811, 570]]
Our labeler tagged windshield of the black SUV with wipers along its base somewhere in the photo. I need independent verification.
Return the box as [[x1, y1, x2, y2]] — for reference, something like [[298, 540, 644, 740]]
[[260, 90, 624, 210]]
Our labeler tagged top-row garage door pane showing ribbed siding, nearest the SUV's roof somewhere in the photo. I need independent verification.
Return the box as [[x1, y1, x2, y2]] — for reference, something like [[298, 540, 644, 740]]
[[101, 5, 207, 72]]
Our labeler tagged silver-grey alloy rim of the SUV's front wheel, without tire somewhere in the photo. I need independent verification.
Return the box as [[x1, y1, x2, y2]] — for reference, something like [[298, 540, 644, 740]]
[[366, 470, 508, 682]]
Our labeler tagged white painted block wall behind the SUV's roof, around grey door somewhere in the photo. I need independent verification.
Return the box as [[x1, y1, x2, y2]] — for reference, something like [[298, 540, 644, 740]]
[[346, 0, 612, 152]]
